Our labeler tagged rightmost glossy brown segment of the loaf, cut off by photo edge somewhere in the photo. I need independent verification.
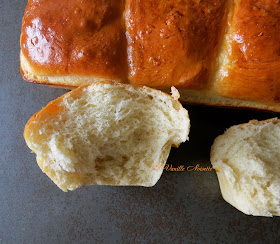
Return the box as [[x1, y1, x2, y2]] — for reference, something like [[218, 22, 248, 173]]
[[213, 0, 280, 107]]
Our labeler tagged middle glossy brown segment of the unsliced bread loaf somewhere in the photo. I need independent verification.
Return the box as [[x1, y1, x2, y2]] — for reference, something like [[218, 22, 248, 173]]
[[125, 0, 226, 90]]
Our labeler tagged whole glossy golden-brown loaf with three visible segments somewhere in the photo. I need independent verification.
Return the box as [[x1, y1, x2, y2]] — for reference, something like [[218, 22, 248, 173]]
[[20, 0, 280, 111]]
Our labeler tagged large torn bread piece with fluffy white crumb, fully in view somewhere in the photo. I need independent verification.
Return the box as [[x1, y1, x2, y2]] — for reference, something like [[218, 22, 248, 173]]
[[24, 82, 190, 191]]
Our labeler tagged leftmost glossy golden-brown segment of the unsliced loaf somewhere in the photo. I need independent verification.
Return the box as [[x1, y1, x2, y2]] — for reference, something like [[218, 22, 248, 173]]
[[21, 0, 127, 83]]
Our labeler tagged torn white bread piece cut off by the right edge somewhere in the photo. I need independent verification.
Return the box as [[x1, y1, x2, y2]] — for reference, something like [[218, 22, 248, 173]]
[[211, 118, 280, 216]]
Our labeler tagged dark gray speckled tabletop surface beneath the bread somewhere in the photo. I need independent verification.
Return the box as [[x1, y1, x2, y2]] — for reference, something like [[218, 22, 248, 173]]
[[0, 0, 280, 243]]
